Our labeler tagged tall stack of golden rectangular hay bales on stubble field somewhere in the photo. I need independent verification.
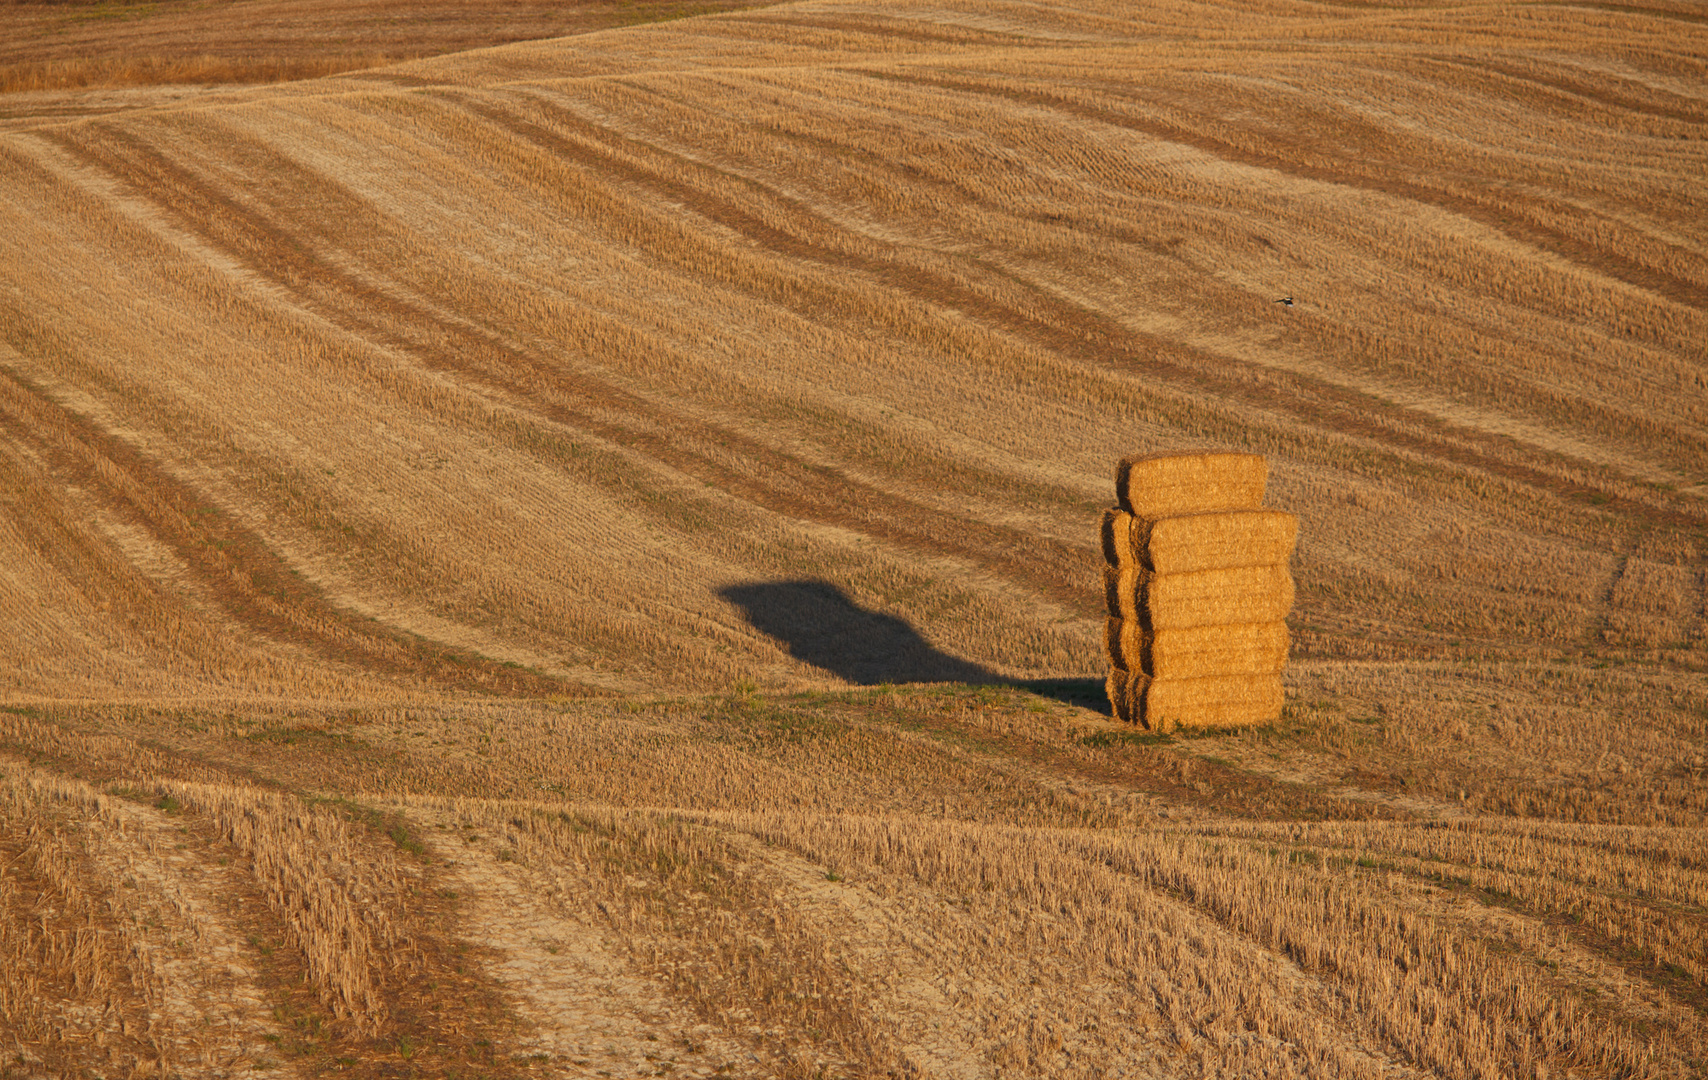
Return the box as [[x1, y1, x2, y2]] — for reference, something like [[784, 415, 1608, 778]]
[[1103, 453, 1298, 731]]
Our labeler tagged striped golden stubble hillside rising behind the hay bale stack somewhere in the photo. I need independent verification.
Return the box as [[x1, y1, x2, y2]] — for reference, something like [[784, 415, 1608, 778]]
[[5, 5, 1708, 692]]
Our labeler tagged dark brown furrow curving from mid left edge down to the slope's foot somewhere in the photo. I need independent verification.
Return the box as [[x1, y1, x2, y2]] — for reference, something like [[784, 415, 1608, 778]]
[[0, 362, 593, 696]]
